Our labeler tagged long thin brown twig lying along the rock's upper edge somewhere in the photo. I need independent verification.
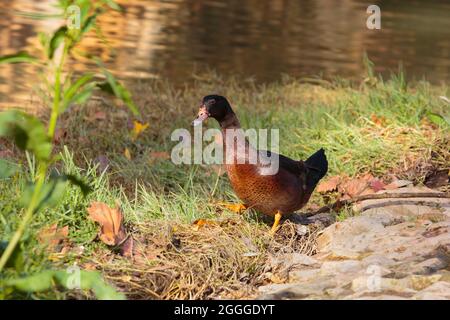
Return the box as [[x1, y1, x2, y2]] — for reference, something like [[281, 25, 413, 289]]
[[305, 192, 450, 217]]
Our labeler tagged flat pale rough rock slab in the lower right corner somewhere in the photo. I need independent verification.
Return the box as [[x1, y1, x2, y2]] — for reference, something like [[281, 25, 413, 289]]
[[260, 186, 450, 299]]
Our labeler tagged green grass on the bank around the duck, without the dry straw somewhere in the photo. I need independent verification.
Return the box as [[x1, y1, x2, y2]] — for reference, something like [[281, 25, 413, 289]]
[[0, 71, 450, 299]]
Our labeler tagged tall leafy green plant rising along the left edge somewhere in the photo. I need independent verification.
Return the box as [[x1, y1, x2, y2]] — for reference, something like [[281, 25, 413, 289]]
[[0, 0, 139, 298]]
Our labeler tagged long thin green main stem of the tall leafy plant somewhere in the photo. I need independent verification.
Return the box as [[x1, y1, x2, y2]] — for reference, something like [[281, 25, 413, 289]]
[[0, 39, 69, 271]]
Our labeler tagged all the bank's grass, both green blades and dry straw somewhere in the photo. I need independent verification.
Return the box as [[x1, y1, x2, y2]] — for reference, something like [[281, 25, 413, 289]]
[[0, 71, 450, 299]]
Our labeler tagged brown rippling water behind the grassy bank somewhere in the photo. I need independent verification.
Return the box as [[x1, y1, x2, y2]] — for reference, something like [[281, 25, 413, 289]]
[[0, 0, 450, 107]]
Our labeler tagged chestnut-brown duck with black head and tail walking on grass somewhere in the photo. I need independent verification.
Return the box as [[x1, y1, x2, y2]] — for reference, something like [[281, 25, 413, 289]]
[[192, 94, 328, 234]]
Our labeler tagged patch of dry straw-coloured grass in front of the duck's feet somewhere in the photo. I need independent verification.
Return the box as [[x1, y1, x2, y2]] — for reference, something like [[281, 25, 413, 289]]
[[87, 216, 320, 299]]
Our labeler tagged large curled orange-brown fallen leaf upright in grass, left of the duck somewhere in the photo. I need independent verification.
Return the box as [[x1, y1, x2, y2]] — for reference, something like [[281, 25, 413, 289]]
[[87, 202, 127, 246]]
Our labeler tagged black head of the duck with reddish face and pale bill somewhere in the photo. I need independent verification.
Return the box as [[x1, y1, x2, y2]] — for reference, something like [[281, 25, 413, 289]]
[[192, 95, 238, 128]]
